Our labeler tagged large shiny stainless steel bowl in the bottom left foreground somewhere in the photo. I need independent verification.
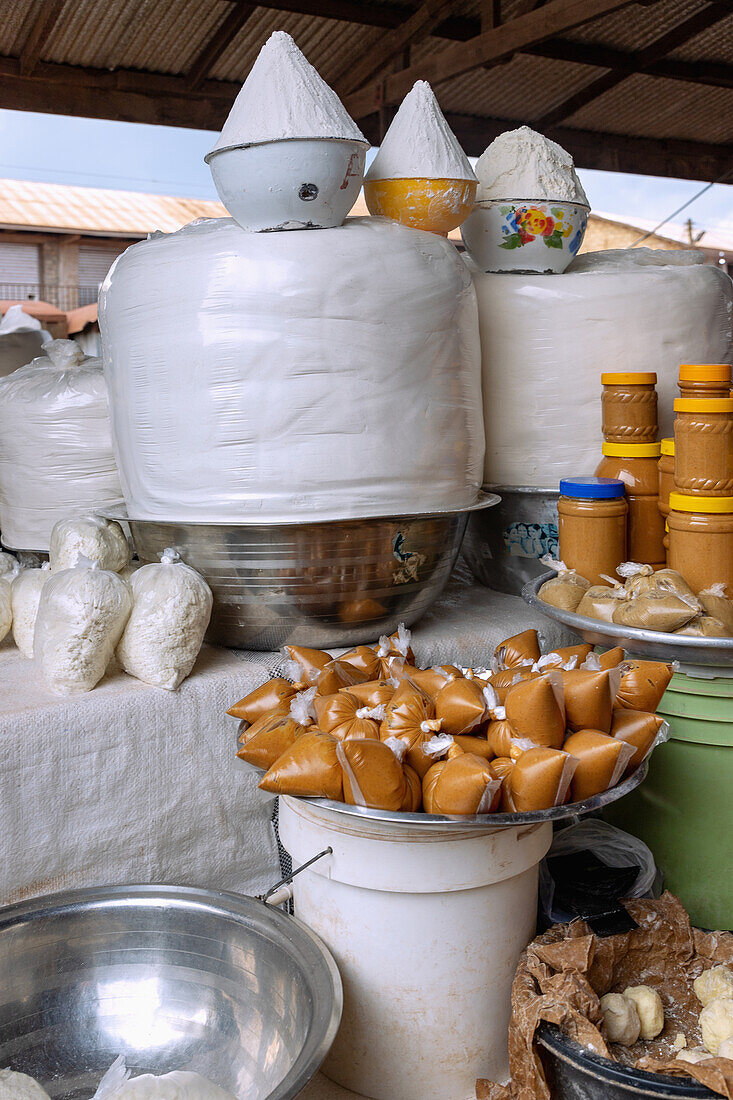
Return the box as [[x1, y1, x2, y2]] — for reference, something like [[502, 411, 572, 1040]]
[[0, 887, 341, 1100]]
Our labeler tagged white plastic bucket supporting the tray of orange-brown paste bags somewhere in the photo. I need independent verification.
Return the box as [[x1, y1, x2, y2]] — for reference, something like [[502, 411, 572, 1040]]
[[280, 798, 553, 1100]]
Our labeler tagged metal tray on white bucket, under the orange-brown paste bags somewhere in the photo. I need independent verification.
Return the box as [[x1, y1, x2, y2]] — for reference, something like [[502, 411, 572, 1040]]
[[247, 758, 648, 833]]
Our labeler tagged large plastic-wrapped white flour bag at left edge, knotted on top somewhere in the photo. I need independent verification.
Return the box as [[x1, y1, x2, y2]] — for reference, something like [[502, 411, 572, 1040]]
[[0, 340, 122, 551]]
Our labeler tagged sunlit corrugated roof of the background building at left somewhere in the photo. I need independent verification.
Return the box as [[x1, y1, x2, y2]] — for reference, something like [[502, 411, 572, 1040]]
[[0, 179, 227, 237]]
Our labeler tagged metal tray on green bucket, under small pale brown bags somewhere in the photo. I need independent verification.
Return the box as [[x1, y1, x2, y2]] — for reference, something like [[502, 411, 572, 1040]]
[[522, 570, 733, 675]]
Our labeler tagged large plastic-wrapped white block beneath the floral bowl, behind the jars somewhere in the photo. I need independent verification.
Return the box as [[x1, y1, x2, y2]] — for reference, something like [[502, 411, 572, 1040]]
[[469, 249, 733, 490]]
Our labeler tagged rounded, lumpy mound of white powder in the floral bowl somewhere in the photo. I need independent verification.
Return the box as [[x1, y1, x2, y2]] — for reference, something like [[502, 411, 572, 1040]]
[[475, 127, 588, 206]]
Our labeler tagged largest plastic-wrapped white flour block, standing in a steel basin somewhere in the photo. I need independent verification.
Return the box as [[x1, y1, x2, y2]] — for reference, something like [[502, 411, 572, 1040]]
[[100, 218, 484, 523]]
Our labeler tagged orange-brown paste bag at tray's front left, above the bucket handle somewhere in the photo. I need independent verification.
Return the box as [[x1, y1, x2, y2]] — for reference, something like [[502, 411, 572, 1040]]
[[260, 732, 343, 802]]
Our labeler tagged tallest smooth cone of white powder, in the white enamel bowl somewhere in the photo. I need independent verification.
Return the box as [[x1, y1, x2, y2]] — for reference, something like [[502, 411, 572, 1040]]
[[206, 31, 369, 161]]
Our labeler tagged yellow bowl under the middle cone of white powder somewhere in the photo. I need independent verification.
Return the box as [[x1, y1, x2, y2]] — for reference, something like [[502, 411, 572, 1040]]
[[364, 178, 478, 237]]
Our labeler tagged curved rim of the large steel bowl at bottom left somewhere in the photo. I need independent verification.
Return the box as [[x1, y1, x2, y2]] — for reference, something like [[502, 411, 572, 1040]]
[[0, 883, 343, 1100]]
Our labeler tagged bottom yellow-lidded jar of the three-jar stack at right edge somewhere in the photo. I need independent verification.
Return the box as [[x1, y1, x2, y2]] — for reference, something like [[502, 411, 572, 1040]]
[[667, 493, 733, 592]]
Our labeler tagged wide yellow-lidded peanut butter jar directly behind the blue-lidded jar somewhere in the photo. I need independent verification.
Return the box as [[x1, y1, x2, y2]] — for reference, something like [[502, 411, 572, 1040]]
[[595, 443, 667, 569]]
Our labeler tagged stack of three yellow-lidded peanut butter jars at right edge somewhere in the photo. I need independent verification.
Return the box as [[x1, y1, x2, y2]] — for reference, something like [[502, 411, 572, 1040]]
[[659, 363, 733, 596]]
